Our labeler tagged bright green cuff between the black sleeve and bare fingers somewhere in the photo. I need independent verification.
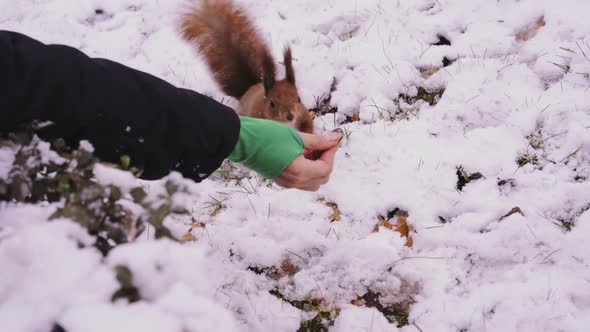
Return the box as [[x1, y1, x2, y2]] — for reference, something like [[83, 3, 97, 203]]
[[228, 116, 304, 179]]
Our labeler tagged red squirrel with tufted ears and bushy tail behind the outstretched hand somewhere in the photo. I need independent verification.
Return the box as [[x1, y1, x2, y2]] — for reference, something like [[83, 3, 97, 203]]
[[180, 0, 314, 133]]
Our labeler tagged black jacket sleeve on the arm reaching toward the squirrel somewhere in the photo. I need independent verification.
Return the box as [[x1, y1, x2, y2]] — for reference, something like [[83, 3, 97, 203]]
[[0, 31, 240, 182]]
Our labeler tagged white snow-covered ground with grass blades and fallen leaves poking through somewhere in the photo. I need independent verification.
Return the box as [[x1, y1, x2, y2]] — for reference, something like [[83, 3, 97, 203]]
[[0, 0, 590, 332]]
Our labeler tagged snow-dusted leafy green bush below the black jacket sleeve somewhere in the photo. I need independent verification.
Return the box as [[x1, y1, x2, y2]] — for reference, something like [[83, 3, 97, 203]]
[[0, 123, 186, 256]]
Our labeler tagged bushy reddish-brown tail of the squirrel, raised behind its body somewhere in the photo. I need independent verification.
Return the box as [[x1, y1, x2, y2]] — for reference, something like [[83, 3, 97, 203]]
[[180, 0, 275, 99]]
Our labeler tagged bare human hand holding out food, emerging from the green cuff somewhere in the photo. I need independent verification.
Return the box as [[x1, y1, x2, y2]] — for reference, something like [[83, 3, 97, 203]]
[[275, 129, 343, 191]]
